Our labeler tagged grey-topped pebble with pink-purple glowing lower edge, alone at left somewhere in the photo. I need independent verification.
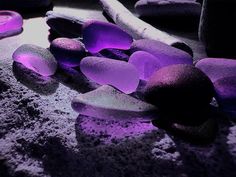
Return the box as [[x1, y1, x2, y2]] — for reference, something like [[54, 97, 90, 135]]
[[12, 44, 57, 76]]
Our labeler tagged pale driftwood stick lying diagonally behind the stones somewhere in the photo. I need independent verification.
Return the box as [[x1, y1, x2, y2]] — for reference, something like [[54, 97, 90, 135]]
[[100, 0, 193, 55]]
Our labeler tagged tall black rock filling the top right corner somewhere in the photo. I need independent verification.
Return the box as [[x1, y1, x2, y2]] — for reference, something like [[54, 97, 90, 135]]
[[199, 0, 236, 58]]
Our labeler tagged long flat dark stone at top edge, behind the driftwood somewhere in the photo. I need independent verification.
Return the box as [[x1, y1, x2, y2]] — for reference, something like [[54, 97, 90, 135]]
[[135, 0, 201, 17]]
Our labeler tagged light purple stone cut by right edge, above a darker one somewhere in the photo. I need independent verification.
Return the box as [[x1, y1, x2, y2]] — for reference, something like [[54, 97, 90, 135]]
[[196, 58, 236, 82]]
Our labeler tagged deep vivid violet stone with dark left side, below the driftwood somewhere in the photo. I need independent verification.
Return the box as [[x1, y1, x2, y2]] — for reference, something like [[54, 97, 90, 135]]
[[82, 20, 133, 53]]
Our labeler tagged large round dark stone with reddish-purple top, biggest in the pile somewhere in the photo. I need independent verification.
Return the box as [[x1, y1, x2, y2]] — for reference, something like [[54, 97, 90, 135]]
[[144, 64, 214, 123]]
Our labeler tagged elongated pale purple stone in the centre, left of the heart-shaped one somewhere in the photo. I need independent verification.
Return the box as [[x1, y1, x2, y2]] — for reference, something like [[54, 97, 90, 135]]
[[80, 57, 139, 94]]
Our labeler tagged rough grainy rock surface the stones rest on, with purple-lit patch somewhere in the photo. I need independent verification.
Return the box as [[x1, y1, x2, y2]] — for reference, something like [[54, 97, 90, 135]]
[[0, 0, 236, 177]]
